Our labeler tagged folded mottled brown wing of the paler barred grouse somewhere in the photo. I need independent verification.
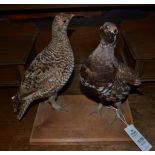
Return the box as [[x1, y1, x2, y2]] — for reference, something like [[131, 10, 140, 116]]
[[20, 53, 63, 96]]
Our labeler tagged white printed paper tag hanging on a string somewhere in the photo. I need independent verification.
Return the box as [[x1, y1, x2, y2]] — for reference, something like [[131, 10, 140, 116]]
[[124, 124, 152, 151]]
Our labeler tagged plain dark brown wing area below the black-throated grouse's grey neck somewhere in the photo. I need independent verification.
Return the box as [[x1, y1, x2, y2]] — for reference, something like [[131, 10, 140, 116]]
[[80, 59, 116, 87]]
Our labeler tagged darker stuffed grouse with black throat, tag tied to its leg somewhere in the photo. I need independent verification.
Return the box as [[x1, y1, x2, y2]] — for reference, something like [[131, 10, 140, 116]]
[[80, 22, 141, 115]]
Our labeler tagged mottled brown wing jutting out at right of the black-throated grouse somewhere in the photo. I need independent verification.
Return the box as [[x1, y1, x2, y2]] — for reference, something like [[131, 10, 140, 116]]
[[116, 63, 141, 86]]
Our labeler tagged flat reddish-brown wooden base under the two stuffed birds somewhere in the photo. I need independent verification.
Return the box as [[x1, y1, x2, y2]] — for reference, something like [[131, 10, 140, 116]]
[[30, 95, 133, 145]]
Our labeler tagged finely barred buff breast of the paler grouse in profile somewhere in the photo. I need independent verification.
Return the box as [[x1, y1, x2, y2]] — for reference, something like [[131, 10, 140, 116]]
[[46, 40, 74, 90]]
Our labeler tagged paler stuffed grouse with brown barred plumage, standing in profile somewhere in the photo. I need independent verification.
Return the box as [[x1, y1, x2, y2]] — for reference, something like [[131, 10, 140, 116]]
[[12, 13, 74, 120]]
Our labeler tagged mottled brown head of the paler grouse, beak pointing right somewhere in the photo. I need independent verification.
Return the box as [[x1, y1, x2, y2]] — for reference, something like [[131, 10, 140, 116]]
[[52, 13, 74, 32]]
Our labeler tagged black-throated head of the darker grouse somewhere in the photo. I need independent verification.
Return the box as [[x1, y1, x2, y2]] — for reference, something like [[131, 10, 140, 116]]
[[100, 22, 118, 43]]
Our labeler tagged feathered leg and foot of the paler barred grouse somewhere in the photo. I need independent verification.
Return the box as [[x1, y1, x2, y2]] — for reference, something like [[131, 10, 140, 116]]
[[48, 95, 67, 111]]
